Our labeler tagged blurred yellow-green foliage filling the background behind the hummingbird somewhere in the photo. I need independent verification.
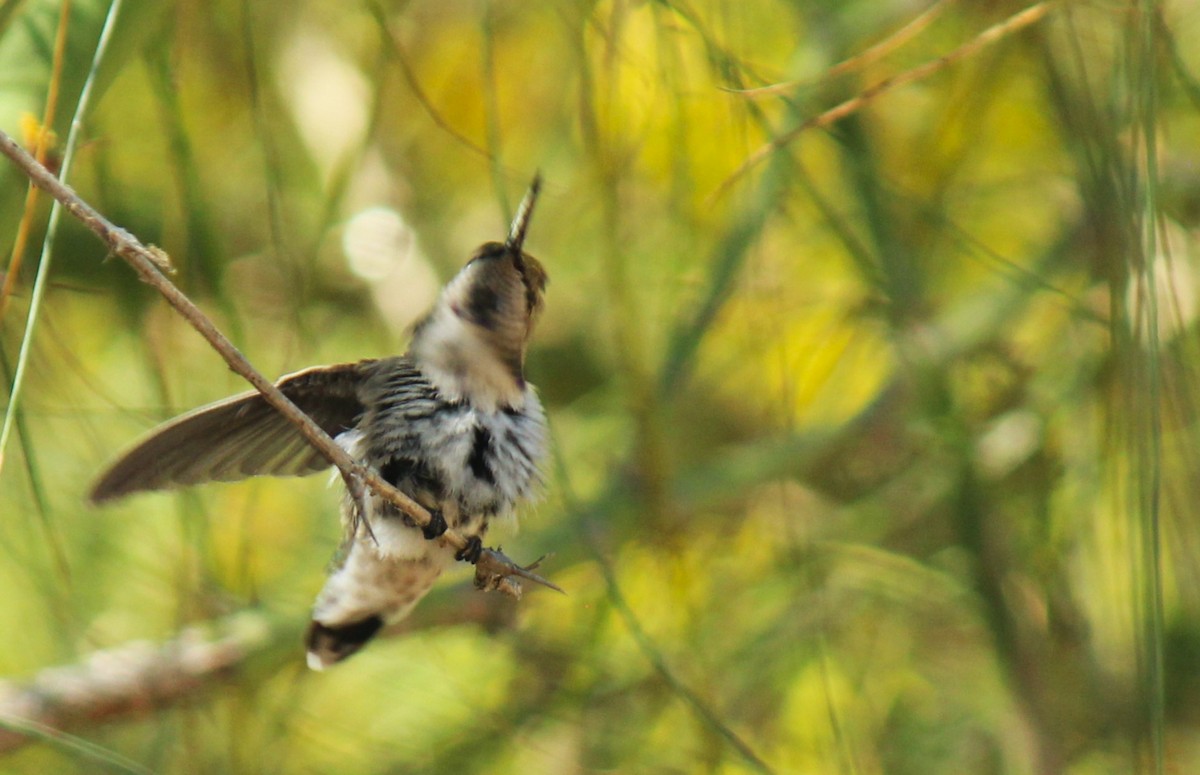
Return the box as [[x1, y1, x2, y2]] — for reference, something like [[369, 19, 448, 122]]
[[0, 0, 1200, 775]]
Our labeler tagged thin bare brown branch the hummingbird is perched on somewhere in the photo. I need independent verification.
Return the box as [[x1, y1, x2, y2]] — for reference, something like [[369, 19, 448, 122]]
[[0, 131, 562, 596]]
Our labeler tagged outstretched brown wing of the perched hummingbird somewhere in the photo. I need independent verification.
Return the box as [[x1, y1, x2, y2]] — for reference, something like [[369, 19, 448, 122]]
[[91, 360, 379, 503]]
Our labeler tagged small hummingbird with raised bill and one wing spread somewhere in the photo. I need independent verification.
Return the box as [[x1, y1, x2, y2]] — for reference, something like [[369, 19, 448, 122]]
[[90, 178, 547, 671]]
